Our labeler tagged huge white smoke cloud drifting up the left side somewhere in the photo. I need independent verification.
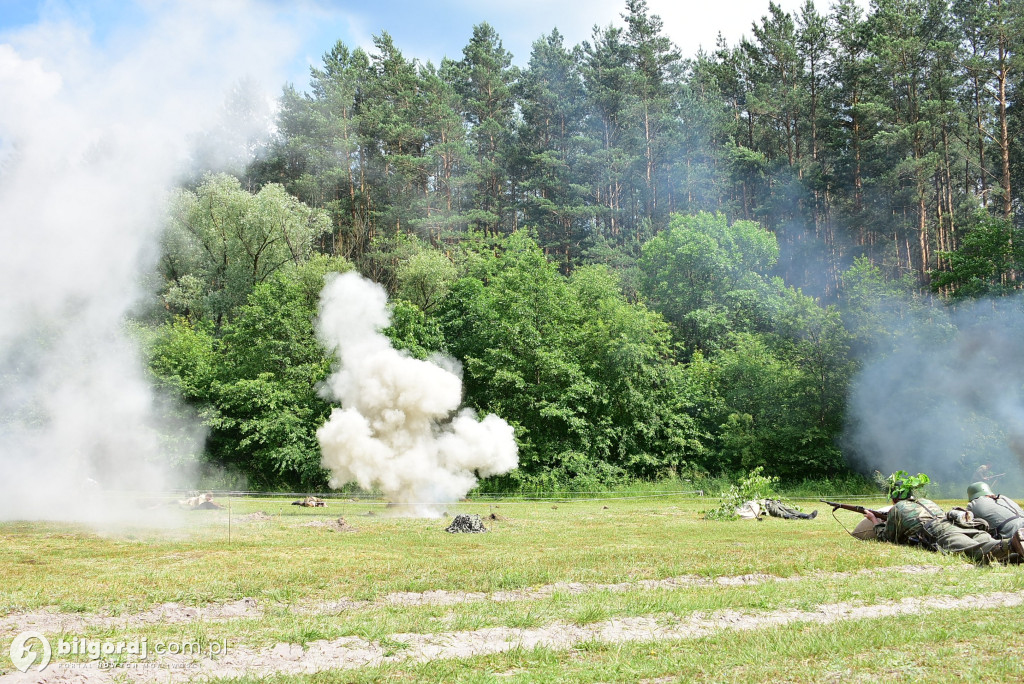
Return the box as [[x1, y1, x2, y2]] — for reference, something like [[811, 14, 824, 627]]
[[0, 2, 305, 519]]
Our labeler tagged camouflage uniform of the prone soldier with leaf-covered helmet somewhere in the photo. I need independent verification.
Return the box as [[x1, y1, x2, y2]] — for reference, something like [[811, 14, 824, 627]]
[[874, 497, 1020, 563]]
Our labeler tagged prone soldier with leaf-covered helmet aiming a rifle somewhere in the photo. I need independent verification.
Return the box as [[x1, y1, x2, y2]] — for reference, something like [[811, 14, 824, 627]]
[[864, 470, 1024, 563]]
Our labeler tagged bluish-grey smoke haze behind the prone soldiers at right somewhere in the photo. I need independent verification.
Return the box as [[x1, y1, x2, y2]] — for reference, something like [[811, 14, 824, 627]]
[[848, 297, 1024, 497]]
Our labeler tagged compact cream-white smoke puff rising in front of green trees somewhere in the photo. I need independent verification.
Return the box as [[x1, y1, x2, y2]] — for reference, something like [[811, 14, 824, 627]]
[[316, 272, 518, 516]]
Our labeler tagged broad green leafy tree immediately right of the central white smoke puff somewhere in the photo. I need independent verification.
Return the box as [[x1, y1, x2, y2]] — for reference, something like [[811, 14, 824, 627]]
[[440, 232, 703, 482]]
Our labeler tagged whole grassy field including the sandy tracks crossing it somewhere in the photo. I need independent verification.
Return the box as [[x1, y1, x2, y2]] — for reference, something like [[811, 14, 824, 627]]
[[0, 497, 1024, 682]]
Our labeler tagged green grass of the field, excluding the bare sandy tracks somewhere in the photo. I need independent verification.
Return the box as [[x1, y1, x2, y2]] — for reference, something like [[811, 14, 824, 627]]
[[0, 497, 1024, 682]]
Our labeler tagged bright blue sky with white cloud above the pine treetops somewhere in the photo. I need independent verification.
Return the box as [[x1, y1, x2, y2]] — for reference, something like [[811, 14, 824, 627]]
[[0, 0, 866, 92]]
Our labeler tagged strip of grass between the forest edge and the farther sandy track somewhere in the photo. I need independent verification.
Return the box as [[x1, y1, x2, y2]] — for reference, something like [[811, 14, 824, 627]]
[[0, 499, 934, 612]]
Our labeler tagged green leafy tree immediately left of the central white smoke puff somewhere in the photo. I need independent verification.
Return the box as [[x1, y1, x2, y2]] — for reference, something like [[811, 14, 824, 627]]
[[150, 258, 349, 488]]
